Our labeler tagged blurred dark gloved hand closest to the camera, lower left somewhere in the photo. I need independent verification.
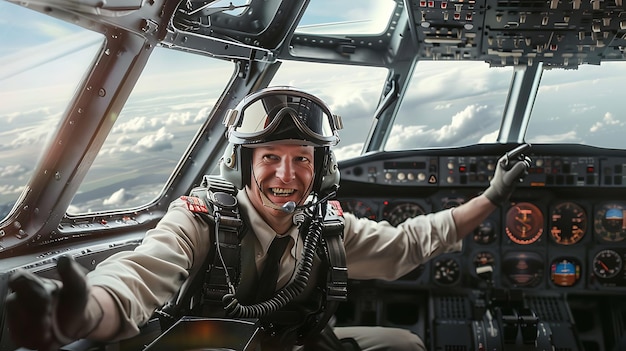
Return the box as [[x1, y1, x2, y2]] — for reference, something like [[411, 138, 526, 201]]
[[6, 255, 103, 350]]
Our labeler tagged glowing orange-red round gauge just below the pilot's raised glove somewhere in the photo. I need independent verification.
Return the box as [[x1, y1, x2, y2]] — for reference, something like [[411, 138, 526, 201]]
[[504, 202, 543, 245]]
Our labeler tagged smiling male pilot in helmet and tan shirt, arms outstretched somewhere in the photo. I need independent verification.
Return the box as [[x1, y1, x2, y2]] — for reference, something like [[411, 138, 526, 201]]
[[6, 87, 530, 351]]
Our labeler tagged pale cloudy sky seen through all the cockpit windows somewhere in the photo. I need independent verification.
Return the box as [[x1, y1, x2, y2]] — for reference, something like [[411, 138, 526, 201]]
[[0, 0, 626, 217]]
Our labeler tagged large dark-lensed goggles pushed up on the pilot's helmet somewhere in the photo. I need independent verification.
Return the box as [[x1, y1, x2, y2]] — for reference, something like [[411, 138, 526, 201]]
[[224, 87, 343, 146]]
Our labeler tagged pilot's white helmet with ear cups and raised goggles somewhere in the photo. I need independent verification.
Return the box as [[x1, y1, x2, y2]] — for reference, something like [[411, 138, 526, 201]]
[[220, 86, 343, 195]]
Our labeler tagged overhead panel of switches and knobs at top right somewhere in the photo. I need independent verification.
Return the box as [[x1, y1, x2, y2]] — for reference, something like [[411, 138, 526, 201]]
[[410, 0, 626, 68]]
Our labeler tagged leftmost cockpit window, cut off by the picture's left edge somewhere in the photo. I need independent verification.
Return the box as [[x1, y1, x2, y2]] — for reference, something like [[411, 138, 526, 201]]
[[0, 1, 104, 221]]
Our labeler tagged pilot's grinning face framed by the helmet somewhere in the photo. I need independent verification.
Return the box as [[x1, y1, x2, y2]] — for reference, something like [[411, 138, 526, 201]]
[[249, 144, 315, 216]]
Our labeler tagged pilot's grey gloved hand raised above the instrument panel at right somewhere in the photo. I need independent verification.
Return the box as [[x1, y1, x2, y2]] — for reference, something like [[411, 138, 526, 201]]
[[484, 144, 531, 205]]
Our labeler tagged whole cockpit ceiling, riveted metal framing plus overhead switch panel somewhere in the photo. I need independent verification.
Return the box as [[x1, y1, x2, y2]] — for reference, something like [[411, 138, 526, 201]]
[[174, 0, 626, 68]]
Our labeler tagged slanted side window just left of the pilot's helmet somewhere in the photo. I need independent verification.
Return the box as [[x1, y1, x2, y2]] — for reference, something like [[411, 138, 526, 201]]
[[67, 47, 234, 214]]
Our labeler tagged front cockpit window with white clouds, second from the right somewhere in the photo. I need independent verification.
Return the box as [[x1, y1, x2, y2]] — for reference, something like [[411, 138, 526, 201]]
[[385, 61, 513, 151]]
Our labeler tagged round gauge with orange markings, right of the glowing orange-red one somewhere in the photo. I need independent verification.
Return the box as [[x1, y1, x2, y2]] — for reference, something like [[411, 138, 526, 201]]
[[550, 202, 587, 245]]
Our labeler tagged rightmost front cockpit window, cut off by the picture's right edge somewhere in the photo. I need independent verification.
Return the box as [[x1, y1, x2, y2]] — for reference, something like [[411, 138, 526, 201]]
[[526, 62, 626, 149]]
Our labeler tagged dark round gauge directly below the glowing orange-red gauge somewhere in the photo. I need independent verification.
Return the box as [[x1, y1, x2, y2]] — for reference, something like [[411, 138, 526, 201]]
[[502, 252, 544, 287]]
